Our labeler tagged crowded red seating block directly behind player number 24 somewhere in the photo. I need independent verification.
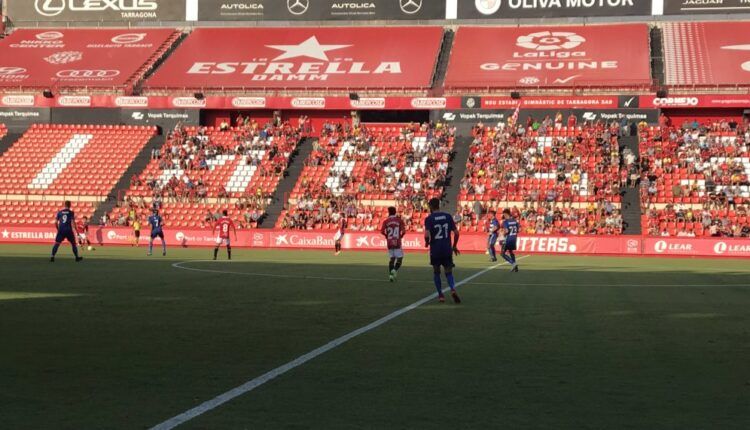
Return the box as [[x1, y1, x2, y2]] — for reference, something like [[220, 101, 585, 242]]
[[276, 124, 455, 231]]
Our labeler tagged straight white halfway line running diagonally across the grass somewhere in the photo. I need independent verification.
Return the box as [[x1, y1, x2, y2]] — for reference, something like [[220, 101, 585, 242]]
[[150, 256, 527, 430]]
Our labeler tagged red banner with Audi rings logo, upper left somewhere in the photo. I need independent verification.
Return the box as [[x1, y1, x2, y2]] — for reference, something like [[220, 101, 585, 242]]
[[0, 29, 174, 91]]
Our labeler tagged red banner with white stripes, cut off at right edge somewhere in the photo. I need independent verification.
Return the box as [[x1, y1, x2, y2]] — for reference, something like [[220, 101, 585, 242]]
[[663, 21, 750, 86]]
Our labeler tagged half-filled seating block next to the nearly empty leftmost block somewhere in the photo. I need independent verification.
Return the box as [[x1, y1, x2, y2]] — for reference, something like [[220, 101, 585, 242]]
[[109, 119, 301, 227]]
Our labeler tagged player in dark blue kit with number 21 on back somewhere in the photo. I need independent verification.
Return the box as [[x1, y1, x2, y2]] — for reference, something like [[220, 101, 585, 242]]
[[424, 198, 461, 303]]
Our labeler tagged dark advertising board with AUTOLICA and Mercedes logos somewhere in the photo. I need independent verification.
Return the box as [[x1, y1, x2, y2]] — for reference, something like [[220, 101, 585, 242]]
[[198, 0, 445, 21]]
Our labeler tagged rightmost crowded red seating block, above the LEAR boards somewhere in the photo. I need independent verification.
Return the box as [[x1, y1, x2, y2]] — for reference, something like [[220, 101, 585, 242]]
[[639, 120, 750, 237]]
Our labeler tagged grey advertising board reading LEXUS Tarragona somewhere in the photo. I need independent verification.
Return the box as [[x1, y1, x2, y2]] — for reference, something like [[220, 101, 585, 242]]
[[5, 0, 186, 23]]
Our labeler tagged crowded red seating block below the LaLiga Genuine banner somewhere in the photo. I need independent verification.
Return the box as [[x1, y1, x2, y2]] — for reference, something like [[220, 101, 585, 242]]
[[456, 119, 624, 234]]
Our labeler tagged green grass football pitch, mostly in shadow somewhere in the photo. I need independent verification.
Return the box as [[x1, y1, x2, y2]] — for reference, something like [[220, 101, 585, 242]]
[[0, 246, 750, 430]]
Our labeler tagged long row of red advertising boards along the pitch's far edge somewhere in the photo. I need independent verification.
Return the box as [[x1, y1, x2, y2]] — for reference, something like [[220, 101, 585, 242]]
[[0, 225, 750, 258]]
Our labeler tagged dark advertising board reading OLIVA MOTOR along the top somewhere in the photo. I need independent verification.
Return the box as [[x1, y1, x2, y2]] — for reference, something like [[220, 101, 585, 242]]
[[458, 0, 652, 19]]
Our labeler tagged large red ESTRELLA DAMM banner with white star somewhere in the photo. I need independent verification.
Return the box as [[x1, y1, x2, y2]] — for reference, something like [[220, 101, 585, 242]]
[[146, 27, 443, 89]]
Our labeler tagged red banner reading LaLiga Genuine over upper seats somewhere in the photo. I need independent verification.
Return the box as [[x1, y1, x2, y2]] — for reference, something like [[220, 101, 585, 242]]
[[445, 24, 651, 88]]
